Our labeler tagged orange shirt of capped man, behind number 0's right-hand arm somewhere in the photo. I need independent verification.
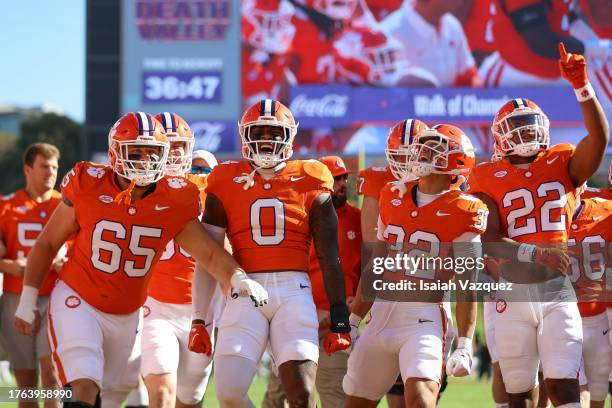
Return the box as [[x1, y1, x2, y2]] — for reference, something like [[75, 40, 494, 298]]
[[308, 202, 361, 310]]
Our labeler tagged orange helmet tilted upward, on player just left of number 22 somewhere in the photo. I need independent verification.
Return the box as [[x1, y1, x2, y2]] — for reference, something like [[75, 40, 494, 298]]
[[407, 124, 476, 184]]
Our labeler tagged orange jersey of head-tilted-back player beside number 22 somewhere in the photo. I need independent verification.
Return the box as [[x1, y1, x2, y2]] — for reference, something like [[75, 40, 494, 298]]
[[378, 182, 488, 282]]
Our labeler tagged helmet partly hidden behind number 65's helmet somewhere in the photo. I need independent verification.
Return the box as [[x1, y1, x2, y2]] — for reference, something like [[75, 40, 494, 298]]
[[155, 112, 195, 176]]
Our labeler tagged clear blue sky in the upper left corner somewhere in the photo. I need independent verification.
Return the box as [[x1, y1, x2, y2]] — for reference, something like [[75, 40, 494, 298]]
[[0, 0, 85, 121]]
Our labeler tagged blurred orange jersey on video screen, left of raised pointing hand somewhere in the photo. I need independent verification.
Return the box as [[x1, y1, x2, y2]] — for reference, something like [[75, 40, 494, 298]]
[[493, 0, 571, 79]]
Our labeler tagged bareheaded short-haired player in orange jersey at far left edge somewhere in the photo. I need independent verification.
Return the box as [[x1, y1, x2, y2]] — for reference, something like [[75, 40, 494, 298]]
[[0, 143, 61, 407]]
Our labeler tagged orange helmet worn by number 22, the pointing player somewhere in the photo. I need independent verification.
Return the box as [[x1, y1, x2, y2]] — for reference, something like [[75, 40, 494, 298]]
[[491, 98, 550, 157]]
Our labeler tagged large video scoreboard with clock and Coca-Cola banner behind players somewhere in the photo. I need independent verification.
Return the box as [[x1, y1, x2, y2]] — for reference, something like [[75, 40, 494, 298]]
[[121, 0, 612, 155]]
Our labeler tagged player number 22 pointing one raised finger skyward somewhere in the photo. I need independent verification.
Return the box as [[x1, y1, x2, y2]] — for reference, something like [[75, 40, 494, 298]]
[[469, 44, 609, 407]]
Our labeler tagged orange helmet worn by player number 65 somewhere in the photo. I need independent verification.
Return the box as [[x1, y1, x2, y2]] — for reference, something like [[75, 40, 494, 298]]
[[108, 112, 170, 186]]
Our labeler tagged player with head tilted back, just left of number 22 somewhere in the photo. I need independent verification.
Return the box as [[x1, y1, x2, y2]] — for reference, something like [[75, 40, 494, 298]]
[[343, 125, 487, 408]]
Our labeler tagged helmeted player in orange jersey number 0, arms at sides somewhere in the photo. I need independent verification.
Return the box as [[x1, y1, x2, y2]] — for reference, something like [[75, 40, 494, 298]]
[[204, 99, 350, 407]]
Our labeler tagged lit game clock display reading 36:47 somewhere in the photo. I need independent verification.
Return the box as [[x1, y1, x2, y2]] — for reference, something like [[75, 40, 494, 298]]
[[142, 71, 221, 103]]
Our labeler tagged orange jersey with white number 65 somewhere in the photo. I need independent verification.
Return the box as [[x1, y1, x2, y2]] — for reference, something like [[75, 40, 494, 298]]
[[60, 162, 200, 314]]
